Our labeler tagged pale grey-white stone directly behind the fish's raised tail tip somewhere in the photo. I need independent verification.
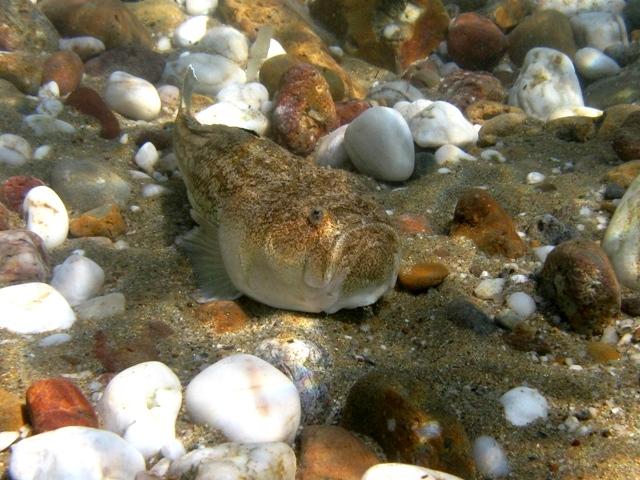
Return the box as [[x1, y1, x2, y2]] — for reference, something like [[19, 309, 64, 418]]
[[163, 53, 246, 97]]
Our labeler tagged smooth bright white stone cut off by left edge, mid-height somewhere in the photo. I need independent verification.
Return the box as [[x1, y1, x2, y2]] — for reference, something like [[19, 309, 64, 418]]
[[0, 282, 76, 333]]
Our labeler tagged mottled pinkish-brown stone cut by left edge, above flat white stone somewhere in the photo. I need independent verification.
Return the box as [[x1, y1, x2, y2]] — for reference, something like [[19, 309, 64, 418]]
[[0, 230, 51, 285]]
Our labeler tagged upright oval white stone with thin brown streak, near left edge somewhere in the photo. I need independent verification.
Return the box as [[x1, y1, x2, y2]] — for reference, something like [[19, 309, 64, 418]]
[[22, 185, 69, 250]]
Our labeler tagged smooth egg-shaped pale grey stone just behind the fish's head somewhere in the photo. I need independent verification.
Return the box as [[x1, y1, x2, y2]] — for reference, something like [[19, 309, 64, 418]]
[[344, 107, 415, 182]]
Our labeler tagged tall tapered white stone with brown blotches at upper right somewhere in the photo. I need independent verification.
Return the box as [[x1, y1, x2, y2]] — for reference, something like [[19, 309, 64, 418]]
[[509, 47, 584, 120]]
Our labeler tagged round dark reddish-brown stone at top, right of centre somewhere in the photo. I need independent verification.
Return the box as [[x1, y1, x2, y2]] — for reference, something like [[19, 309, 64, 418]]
[[447, 12, 507, 71]]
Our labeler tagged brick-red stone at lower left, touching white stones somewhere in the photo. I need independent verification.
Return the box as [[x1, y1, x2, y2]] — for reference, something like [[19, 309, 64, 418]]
[[27, 378, 98, 433]]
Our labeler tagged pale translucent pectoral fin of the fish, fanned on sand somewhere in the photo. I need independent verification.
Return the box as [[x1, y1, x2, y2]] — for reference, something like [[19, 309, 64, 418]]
[[178, 227, 242, 301]]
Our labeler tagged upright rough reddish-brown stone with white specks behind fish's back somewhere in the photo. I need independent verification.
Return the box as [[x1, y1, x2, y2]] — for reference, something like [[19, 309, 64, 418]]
[[272, 64, 338, 155]]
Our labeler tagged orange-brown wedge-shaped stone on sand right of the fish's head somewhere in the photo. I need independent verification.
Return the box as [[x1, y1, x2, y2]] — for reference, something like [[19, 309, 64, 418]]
[[451, 188, 526, 258]]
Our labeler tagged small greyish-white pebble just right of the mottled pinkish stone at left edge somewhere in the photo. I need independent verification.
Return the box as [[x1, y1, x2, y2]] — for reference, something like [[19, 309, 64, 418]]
[[51, 254, 104, 306]]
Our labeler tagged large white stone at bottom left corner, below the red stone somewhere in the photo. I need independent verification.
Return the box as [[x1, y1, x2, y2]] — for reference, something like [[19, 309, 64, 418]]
[[9, 427, 145, 480]]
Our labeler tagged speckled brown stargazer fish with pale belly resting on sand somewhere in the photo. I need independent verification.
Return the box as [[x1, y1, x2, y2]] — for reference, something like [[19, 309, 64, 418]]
[[174, 69, 399, 313]]
